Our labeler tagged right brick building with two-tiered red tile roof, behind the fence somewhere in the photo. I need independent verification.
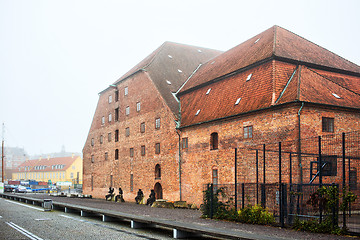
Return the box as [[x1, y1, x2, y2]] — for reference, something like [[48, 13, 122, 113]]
[[178, 26, 360, 206]]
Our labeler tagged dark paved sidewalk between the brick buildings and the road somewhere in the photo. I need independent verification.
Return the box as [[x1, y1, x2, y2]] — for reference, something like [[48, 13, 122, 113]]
[[3, 194, 354, 240]]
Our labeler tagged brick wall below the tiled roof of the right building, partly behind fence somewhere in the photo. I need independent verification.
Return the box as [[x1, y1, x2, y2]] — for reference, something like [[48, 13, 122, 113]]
[[182, 103, 360, 204]]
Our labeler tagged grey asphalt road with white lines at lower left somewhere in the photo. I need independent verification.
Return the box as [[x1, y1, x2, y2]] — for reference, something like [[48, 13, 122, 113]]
[[0, 198, 173, 240]]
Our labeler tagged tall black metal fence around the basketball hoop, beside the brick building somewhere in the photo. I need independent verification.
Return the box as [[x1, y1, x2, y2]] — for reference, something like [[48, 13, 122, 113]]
[[206, 132, 360, 233]]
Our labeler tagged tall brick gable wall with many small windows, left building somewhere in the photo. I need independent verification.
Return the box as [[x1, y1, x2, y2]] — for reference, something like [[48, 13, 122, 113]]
[[83, 72, 179, 201]]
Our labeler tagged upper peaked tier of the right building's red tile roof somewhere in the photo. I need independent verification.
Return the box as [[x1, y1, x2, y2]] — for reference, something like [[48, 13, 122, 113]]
[[180, 26, 360, 95]]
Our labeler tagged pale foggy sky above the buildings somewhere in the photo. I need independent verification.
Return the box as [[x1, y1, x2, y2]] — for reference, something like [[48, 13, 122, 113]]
[[0, 0, 360, 154]]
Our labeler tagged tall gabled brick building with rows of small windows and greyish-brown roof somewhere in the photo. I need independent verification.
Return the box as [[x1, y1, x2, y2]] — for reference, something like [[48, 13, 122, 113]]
[[83, 42, 220, 201]]
